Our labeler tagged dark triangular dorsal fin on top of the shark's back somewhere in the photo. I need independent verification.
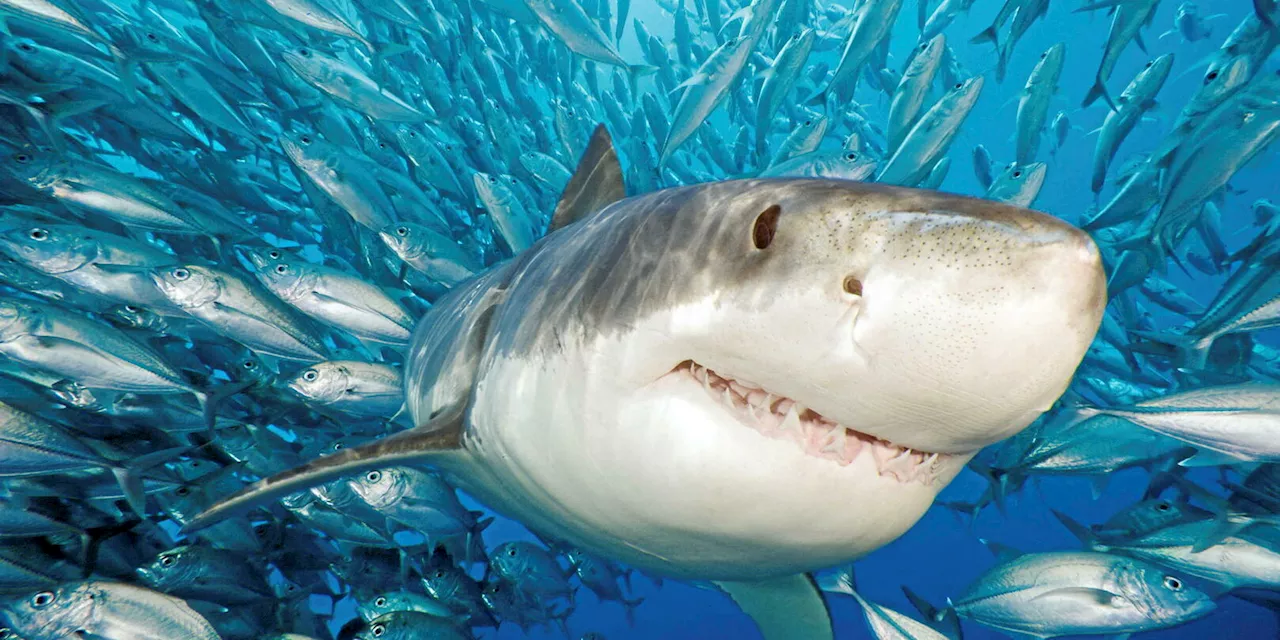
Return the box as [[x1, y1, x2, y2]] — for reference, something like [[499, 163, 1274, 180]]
[[547, 124, 627, 233]]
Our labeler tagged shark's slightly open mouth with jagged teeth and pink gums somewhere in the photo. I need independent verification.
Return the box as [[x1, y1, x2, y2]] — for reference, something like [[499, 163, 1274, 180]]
[[672, 360, 951, 486]]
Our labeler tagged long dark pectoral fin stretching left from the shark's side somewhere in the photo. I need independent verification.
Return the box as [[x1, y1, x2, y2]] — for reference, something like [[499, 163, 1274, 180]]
[[183, 406, 466, 532]]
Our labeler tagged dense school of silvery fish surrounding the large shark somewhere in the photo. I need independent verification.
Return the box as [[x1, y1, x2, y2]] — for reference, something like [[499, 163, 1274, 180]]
[[0, 0, 1280, 640]]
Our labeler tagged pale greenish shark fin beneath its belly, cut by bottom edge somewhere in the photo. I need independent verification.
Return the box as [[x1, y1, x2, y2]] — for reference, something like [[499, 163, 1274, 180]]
[[716, 573, 836, 640]]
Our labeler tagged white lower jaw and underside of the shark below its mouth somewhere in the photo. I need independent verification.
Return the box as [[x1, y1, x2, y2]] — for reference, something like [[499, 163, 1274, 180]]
[[458, 348, 968, 580]]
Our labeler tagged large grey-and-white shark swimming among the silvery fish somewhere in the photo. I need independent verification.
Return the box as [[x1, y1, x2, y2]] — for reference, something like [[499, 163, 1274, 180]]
[[188, 128, 1106, 640]]
